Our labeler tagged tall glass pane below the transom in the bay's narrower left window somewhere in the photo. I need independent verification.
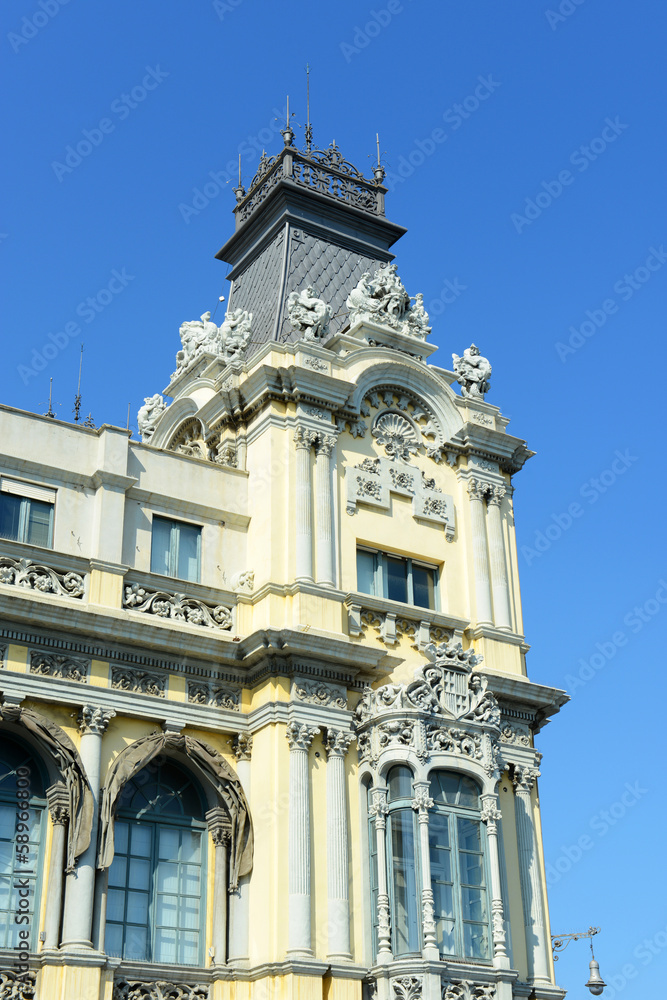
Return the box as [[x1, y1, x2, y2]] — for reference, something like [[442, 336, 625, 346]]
[[389, 809, 419, 955]]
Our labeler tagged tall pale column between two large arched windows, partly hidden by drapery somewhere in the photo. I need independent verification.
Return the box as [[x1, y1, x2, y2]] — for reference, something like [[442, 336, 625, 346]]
[[62, 705, 116, 949]]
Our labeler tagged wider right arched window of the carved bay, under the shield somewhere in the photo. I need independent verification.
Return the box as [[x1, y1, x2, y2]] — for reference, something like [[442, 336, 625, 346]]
[[428, 771, 491, 960]]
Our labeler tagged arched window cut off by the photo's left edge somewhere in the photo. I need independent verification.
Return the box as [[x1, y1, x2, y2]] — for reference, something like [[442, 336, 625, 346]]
[[0, 734, 46, 951]]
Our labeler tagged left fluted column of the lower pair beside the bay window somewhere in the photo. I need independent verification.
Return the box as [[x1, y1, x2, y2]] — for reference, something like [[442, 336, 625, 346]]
[[285, 722, 319, 958]]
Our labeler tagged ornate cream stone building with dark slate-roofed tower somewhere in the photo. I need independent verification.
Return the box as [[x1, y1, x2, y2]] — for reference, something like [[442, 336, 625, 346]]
[[0, 128, 566, 1000]]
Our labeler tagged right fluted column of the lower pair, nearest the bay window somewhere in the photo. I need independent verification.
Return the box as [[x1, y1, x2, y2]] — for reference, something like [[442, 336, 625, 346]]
[[325, 729, 354, 962]]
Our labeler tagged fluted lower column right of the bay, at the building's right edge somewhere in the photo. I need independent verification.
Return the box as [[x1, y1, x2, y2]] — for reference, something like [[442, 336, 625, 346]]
[[514, 767, 550, 983]]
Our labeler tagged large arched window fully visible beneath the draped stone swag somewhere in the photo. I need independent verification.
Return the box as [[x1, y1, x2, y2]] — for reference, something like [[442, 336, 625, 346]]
[[105, 758, 207, 965]]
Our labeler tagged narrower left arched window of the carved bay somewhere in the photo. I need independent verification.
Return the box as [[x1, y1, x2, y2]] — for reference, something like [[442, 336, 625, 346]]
[[387, 764, 421, 957]]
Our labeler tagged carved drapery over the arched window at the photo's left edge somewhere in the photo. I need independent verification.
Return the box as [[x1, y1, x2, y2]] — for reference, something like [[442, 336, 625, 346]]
[[0, 705, 94, 872]]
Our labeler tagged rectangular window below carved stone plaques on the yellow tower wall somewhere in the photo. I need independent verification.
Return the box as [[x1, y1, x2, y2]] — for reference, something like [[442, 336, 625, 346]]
[[357, 549, 438, 611]]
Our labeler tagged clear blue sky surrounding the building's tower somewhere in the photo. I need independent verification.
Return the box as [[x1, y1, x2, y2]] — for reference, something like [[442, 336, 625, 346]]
[[0, 0, 667, 1000]]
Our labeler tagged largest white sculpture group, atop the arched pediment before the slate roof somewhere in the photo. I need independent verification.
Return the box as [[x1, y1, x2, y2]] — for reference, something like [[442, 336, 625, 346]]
[[347, 264, 431, 340]]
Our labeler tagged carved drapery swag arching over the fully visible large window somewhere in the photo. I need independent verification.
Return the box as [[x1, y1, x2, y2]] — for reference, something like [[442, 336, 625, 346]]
[[97, 733, 254, 892]]
